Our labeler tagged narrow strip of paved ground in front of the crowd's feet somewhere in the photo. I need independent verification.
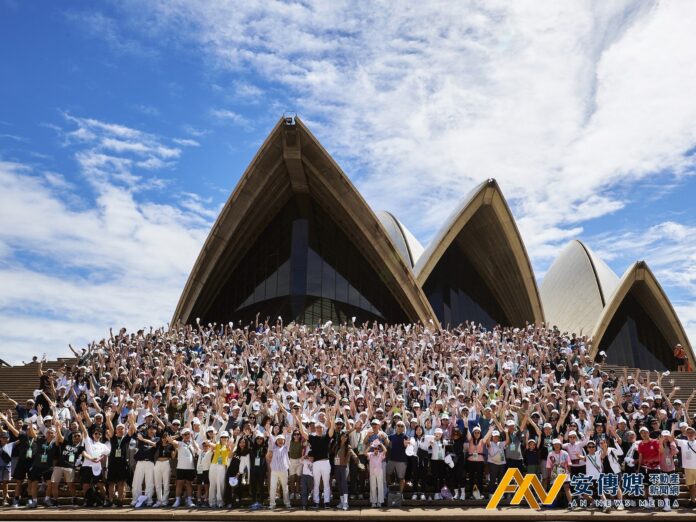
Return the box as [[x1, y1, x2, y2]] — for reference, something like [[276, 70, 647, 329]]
[[0, 507, 696, 522]]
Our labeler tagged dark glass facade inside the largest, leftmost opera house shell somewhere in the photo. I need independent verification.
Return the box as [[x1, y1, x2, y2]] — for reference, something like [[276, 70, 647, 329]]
[[204, 199, 406, 324]]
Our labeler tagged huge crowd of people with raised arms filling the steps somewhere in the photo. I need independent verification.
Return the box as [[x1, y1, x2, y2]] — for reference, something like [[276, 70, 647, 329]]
[[0, 314, 696, 510]]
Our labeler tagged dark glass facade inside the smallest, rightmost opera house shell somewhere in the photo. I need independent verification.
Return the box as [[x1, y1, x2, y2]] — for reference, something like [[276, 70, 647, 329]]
[[599, 293, 676, 371]]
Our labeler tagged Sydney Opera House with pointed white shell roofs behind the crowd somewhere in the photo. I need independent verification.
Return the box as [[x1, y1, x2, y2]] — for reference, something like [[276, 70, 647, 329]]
[[172, 118, 693, 369]]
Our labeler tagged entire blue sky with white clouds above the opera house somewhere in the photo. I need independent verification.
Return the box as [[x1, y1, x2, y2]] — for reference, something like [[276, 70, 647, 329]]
[[0, 0, 696, 362]]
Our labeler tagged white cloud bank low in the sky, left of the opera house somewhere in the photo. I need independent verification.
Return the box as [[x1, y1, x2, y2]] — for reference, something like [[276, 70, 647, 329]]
[[0, 117, 213, 361]]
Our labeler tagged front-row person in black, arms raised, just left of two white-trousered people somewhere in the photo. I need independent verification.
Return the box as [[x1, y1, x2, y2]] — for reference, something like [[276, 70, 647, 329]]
[[104, 410, 135, 507]]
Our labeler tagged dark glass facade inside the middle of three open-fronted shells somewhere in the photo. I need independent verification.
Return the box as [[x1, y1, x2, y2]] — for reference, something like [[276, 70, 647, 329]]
[[423, 242, 510, 328]]
